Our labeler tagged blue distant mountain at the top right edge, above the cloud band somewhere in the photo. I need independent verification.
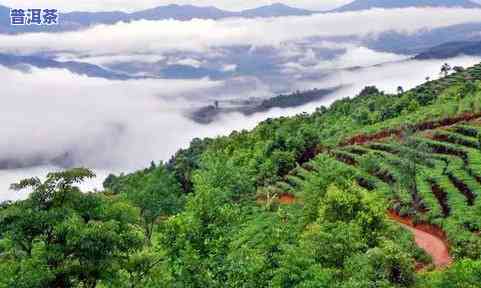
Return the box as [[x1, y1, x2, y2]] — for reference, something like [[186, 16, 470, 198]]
[[333, 0, 481, 12]]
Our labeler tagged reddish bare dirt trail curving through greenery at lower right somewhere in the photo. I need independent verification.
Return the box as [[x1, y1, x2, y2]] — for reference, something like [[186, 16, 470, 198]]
[[389, 212, 453, 268]]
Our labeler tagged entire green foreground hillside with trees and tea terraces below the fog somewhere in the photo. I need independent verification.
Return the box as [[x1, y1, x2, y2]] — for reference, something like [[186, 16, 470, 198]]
[[0, 64, 481, 288]]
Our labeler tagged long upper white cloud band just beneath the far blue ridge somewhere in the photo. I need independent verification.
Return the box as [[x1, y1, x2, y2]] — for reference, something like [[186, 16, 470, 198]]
[[0, 8, 481, 56]]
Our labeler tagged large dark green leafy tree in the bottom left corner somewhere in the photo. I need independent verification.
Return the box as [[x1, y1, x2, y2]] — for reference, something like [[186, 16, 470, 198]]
[[0, 168, 143, 287]]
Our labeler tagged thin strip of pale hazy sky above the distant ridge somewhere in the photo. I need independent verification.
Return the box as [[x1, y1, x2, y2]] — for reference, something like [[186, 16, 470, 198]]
[[0, 0, 352, 11]]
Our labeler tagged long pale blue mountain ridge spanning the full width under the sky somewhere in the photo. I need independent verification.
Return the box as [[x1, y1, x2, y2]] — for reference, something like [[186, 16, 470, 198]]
[[0, 0, 481, 34]]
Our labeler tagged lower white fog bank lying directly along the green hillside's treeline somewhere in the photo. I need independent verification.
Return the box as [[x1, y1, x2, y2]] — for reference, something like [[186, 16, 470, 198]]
[[0, 57, 481, 201]]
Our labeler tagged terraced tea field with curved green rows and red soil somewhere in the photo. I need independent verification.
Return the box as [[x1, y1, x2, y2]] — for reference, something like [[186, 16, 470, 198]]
[[263, 114, 481, 257]]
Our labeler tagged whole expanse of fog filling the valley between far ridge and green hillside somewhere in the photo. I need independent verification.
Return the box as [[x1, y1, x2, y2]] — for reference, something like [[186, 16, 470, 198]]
[[0, 5, 481, 202]]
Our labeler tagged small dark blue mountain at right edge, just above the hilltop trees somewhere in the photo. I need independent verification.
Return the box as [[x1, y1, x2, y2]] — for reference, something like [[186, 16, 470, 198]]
[[415, 41, 481, 60]]
